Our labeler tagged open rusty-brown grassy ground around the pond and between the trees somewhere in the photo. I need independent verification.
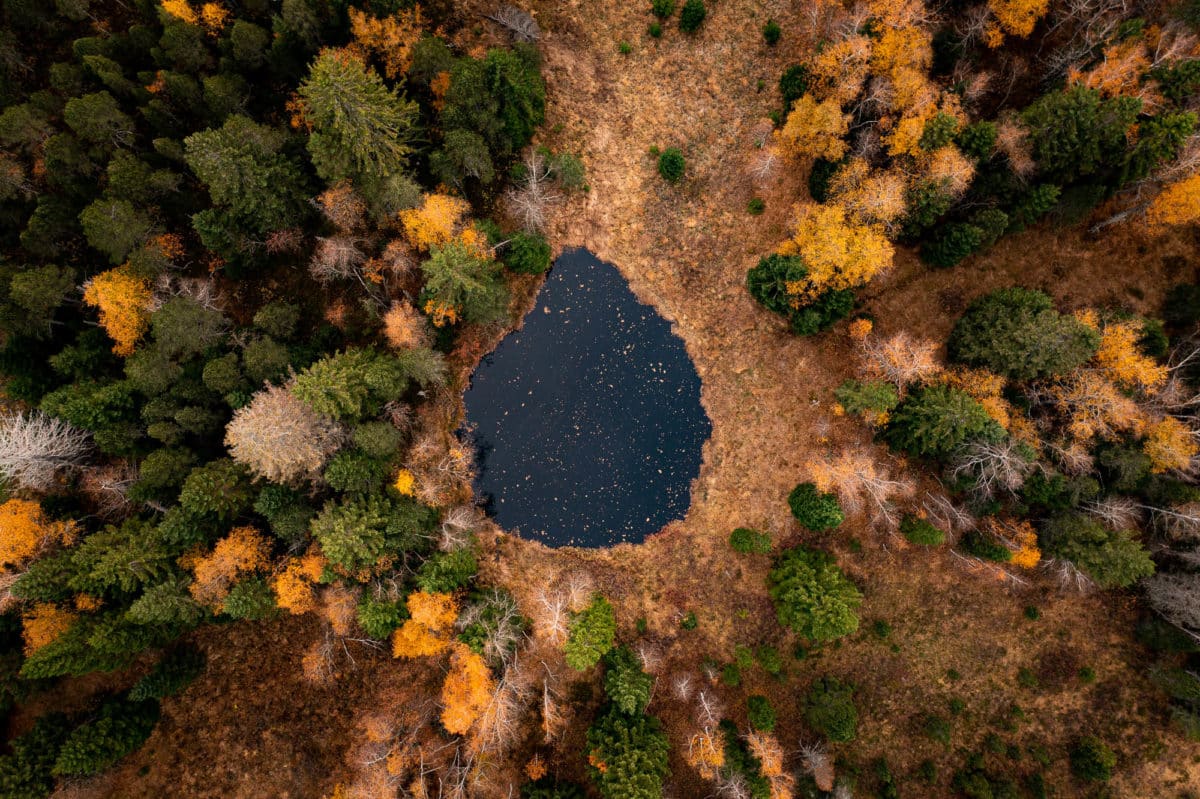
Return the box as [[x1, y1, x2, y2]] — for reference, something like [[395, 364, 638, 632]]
[[62, 0, 1200, 798]]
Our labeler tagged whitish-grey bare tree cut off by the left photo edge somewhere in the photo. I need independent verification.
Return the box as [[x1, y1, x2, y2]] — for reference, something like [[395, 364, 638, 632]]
[[0, 410, 91, 491]]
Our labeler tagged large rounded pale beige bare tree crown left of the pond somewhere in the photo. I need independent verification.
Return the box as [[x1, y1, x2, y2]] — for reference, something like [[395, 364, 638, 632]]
[[226, 385, 344, 482]]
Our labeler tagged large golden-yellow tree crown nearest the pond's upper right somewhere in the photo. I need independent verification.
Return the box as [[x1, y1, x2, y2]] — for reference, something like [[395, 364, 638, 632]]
[[779, 204, 894, 299]]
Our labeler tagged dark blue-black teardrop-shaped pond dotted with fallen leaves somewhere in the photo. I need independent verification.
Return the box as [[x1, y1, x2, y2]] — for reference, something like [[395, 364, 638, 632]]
[[466, 250, 712, 547]]
